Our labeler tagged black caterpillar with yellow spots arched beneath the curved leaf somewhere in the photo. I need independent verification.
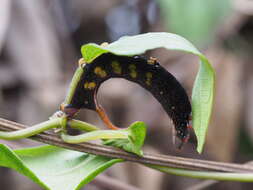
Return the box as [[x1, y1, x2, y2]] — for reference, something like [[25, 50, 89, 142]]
[[60, 53, 191, 146]]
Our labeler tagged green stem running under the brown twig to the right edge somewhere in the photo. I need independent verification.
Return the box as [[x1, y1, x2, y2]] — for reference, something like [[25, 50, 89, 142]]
[[146, 164, 253, 182]]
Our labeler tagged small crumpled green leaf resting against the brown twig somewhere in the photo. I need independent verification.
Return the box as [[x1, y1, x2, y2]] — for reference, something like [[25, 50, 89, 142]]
[[103, 121, 147, 156]]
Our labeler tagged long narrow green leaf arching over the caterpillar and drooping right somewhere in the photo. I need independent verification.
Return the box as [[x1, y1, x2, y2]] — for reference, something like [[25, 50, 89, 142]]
[[81, 32, 215, 153]]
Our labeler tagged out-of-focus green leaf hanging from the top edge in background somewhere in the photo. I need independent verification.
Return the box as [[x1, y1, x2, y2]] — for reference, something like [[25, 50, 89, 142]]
[[158, 0, 231, 46]]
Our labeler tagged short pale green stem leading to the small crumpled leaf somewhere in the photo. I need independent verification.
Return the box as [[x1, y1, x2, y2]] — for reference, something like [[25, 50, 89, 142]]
[[61, 130, 128, 144]]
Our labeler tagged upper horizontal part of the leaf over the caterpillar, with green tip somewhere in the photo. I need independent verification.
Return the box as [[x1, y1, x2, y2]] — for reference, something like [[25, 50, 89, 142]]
[[81, 32, 201, 63]]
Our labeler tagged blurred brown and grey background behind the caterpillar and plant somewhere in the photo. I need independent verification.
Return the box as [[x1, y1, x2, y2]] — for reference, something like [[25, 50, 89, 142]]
[[0, 0, 253, 190]]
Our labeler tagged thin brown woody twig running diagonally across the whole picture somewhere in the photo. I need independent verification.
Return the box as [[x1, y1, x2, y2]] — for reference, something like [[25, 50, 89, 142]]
[[0, 118, 253, 173]]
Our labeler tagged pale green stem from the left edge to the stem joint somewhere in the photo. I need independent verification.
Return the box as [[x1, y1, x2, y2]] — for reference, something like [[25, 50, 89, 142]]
[[0, 118, 61, 140]]
